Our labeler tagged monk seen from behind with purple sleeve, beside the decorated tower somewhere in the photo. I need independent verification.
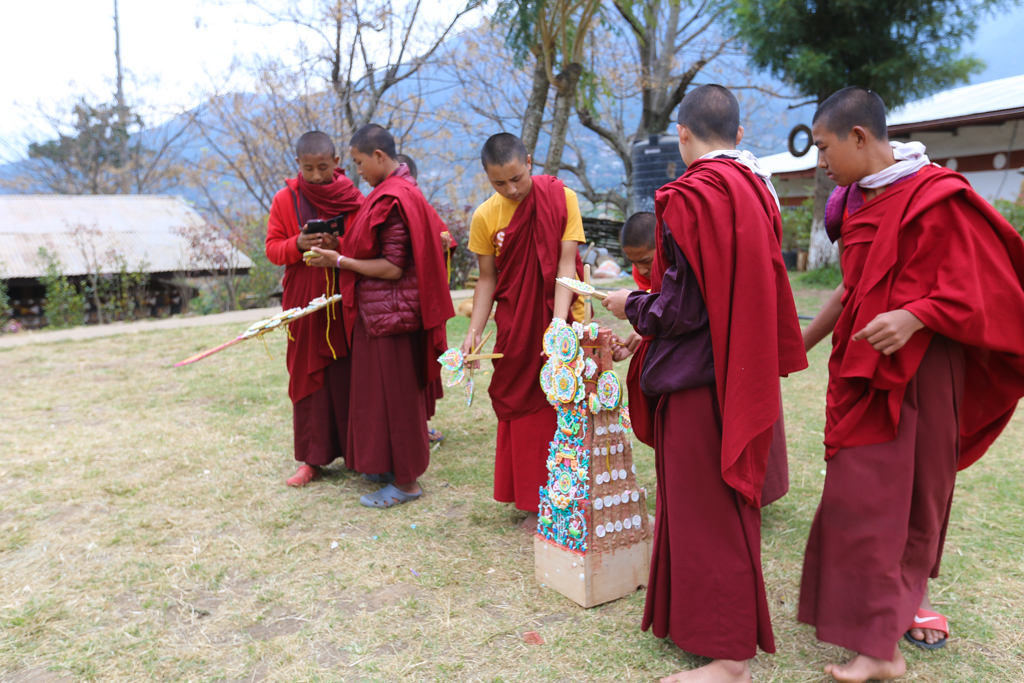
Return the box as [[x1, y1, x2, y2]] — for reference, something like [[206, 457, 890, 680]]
[[604, 85, 807, 683]]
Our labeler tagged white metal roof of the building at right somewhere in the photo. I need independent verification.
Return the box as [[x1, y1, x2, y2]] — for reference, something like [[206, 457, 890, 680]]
[[760, 76, 1024, 173]]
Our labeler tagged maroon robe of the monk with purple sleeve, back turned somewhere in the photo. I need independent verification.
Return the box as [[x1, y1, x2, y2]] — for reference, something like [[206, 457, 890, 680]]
[[630, 160, 807, 660]]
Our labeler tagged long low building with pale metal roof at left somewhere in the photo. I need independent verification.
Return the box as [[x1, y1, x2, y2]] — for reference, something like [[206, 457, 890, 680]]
[[0, 195, 253, 327]]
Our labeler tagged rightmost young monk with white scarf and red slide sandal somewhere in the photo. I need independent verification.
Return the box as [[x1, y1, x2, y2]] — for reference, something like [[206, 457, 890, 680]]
[[799, 87, 1024, 681]]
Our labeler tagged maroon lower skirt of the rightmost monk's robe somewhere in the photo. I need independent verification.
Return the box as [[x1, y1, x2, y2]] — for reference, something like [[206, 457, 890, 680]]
[[797, 336, 965, 659]]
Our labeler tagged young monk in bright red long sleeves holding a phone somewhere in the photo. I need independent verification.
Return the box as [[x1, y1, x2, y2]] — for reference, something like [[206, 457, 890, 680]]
[[266, 131, 362, 486]]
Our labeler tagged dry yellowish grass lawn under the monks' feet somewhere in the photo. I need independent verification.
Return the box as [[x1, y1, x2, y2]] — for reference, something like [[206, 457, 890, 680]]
[[0, 282, 1024, 683]]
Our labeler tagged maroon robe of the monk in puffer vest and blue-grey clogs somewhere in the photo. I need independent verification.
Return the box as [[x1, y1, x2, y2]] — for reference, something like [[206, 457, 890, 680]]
[[340, 165, 455, 484]]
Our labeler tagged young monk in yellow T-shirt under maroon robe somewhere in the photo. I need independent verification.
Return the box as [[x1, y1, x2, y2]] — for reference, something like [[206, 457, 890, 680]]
[[462, 133, 586, 529]]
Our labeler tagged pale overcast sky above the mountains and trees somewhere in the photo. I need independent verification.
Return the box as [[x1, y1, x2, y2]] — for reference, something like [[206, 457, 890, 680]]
[[0, 0, 1024, 159]]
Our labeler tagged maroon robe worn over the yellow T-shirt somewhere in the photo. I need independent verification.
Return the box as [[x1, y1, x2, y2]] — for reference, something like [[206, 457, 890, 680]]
[[487, 175, 583, 512]]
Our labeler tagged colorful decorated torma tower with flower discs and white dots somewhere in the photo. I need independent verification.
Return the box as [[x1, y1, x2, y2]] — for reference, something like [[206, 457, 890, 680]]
[[537, 319, 649, 554]]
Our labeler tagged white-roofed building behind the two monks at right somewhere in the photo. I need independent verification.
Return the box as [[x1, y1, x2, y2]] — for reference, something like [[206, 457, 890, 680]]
[[761, 76, 1024, 206]]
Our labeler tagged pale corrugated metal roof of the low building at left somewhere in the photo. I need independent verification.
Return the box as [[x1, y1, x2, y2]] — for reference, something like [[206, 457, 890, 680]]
[[0, 195, 253, 278]]
